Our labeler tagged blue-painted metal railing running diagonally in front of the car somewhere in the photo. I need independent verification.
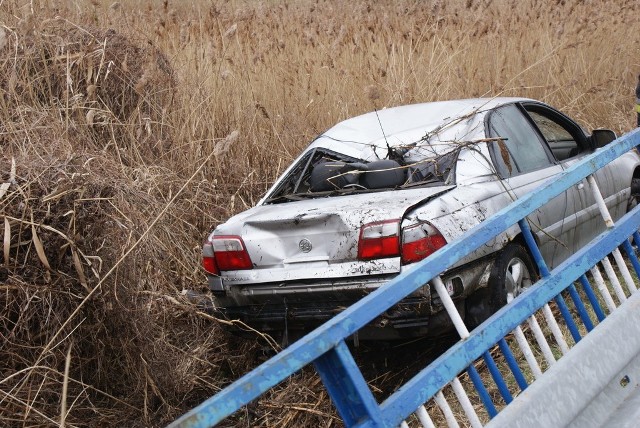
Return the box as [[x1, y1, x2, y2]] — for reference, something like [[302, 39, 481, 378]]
[[170, 125, 640, 427]]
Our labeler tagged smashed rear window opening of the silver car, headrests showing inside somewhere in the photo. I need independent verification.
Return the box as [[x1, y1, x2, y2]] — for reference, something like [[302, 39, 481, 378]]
[[266, 146, 459, 204]]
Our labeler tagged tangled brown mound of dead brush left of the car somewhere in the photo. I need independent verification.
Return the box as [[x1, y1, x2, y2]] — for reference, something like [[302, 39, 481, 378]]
[[0, 15, 249, 425]]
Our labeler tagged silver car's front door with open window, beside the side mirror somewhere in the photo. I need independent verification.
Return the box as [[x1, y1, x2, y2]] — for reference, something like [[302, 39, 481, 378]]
[[524, 103, 616, 254]]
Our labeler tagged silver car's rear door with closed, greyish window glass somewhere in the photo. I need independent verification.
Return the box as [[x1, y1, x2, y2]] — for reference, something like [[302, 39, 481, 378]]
[[487, 104, 581, 267]]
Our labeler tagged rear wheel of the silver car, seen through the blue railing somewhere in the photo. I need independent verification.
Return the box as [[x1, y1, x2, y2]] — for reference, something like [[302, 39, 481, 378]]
[[465, 242, 537, 329]]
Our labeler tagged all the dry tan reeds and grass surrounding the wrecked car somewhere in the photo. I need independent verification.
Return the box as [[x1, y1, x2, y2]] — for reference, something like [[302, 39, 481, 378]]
[[0, 0, 640, 426]]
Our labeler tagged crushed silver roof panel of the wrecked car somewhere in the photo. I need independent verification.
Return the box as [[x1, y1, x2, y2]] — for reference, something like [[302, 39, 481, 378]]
[[310, 97, 533, 159]]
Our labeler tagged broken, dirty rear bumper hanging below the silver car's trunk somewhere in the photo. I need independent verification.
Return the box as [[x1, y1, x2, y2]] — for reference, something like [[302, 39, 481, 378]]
[[202, 259, 493, 340]]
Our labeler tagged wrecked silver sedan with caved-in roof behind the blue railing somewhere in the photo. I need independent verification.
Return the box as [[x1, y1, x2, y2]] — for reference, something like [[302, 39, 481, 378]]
[[202, 98, 640, 340]]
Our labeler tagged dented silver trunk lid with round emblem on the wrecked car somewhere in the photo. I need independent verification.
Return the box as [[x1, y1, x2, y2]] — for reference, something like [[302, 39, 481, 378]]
[[214, 186, 455, 284]]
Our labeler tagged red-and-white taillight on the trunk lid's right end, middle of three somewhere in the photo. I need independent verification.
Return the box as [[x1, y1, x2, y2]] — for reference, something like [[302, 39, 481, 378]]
[[358, 220, 400, 260]]
